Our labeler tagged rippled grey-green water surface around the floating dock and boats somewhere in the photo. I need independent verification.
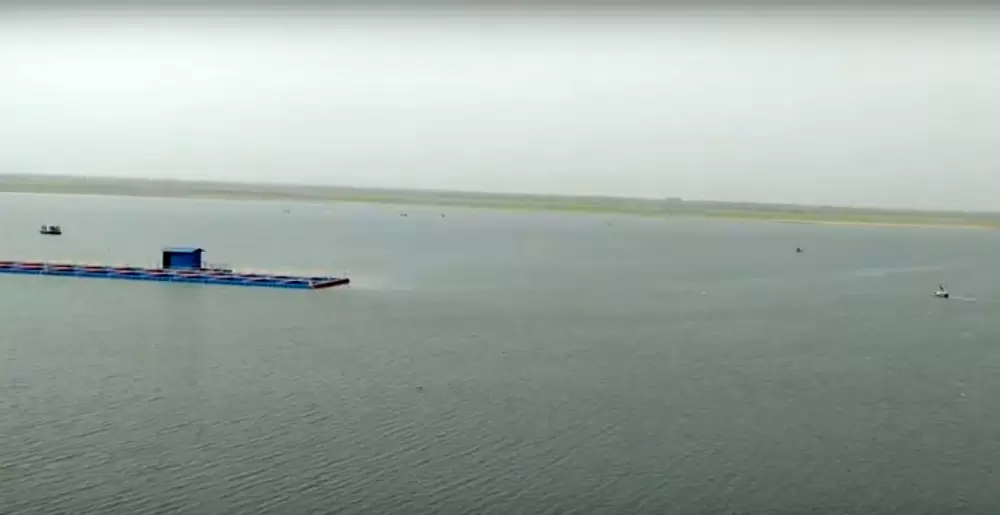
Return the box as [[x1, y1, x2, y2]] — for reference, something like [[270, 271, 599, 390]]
[[0, 191, 1000, 515]]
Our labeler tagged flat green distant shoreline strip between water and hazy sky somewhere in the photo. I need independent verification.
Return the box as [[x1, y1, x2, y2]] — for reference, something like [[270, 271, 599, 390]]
[[0, 175, 1000, 229]]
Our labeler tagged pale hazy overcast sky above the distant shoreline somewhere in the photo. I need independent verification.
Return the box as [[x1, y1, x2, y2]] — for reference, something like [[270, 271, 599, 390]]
[[0, 10, 1000, 210]]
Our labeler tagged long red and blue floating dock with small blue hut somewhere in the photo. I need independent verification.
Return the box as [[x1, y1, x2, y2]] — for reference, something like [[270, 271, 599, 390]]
[[0, 247, 351, 290]]
